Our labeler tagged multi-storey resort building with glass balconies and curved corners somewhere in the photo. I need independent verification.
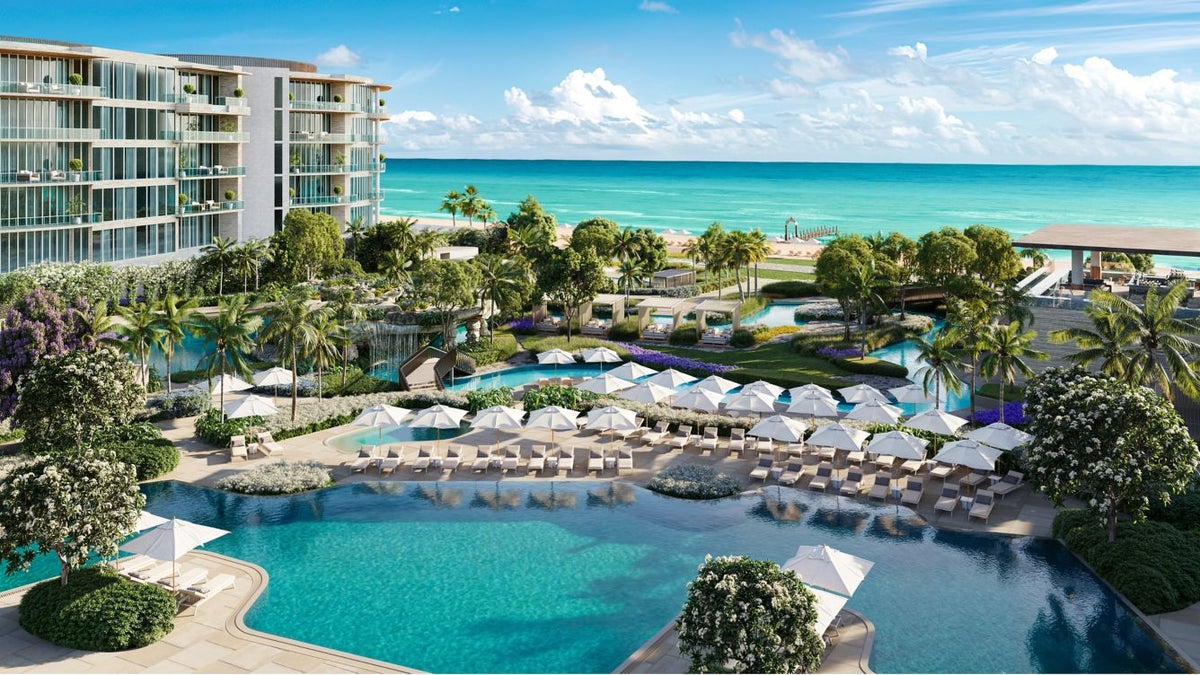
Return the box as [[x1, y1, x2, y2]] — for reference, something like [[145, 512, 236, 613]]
[[0, 36, 389, 273]]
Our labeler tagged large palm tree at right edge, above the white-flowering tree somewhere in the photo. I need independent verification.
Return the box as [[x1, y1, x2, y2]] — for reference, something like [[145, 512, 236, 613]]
[[1050, 280, 1200, 401]]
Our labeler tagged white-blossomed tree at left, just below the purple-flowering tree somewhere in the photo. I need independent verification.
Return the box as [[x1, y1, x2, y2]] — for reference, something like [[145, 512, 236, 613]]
[[12, 347, 145, 454]]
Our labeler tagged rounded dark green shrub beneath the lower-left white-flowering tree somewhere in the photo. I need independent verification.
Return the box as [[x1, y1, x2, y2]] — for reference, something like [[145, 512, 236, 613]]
[[19, 566, 175, 651]]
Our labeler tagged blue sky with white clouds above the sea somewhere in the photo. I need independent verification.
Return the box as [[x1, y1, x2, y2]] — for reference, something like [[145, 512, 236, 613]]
[[14, 0, 1200, 165]]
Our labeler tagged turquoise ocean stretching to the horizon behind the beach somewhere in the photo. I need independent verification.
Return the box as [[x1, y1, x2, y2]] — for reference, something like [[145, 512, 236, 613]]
[[383, 159, 1200, 269]]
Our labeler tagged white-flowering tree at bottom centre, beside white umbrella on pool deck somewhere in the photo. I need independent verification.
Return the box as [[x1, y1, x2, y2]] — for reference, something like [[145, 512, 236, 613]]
[[676, 556, 822, 673]]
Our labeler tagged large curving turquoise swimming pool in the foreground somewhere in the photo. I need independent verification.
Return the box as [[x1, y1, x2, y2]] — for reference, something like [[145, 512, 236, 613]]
[[37, 480, 1181, 673]]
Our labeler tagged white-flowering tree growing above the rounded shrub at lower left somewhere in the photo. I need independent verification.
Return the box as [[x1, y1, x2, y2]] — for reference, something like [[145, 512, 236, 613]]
[[0, 449, 145, 586]]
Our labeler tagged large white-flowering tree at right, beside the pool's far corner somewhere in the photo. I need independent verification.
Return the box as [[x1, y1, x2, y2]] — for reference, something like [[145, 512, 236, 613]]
[[1025, 368, 1200, 542]]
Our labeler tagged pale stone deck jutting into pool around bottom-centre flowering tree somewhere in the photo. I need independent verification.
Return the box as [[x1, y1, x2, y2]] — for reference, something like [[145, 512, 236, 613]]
[[613, 609, 875, 673]]
